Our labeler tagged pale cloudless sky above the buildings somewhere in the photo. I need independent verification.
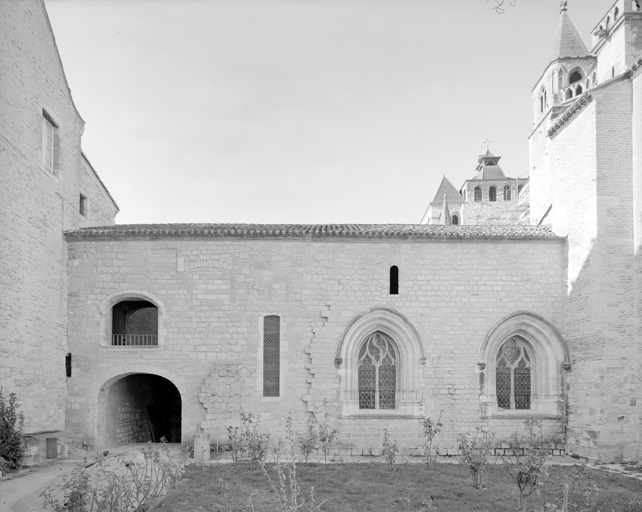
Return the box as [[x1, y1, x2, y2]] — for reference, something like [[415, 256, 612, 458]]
[[46, 0, 613, 224]]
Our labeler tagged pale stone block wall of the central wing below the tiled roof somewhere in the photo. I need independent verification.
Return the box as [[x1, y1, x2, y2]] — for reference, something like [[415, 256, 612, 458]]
[[67, 228, 567, 452]]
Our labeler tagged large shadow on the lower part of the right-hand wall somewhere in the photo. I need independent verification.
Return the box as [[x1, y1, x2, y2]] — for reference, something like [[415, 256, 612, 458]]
[[566, 237, 642, 462]]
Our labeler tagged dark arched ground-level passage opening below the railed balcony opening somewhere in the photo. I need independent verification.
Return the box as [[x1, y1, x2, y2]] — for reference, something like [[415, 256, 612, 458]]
[[98, 373, 182, 446]]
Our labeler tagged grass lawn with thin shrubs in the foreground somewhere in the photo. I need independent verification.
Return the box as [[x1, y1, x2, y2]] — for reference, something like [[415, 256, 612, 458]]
[[158, 463, 642, 512]]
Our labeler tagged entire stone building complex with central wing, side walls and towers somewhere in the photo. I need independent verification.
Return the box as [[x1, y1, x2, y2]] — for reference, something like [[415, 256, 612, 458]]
[[0, 0, 642, 461]]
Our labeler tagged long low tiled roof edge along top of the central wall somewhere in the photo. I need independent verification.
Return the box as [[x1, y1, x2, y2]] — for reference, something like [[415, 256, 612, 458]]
[[65, 224, 561, 242]]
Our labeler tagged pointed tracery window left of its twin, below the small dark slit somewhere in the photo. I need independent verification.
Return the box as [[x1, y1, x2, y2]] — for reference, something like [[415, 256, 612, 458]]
[[358, 331, 397, 409]]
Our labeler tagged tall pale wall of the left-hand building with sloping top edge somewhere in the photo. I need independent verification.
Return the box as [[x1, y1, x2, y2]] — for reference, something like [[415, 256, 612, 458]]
[[0, 0, 116, 433]]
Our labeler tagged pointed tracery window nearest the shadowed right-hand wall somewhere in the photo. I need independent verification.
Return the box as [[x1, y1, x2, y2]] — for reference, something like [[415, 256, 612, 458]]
[[495, 338, 533, 409]]
